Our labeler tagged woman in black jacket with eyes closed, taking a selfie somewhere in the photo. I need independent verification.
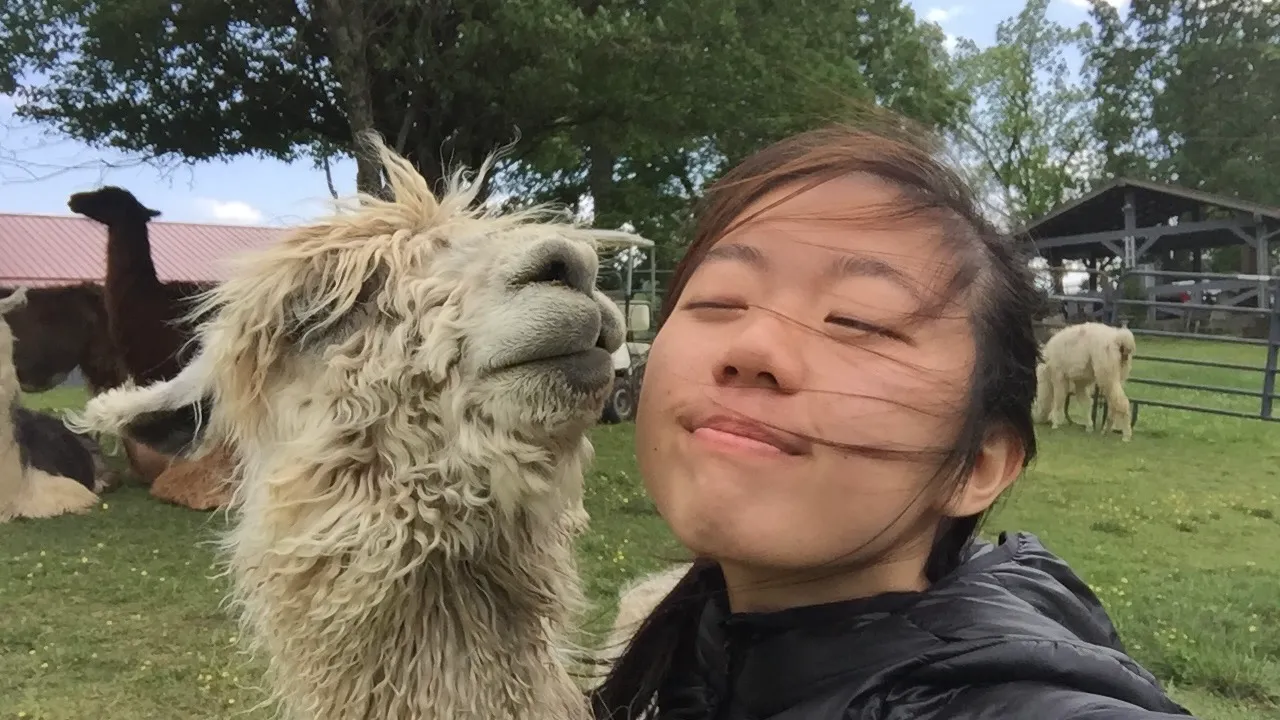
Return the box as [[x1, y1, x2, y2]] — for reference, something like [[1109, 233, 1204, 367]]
[[594, 123, 1187, 720]]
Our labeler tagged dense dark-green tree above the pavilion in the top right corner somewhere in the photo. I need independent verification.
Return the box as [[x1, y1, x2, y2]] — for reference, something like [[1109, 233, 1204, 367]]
[[1089, 0, 1280, 272]]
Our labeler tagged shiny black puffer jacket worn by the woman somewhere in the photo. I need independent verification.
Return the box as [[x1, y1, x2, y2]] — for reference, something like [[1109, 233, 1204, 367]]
[[662, 533, 1178, 719]]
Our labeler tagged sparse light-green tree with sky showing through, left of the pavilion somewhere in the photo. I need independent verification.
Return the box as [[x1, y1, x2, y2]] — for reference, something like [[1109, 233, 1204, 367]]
[[954, 0, 1100, 227]]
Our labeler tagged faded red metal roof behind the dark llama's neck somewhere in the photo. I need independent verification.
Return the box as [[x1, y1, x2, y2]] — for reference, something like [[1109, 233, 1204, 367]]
[[0, 213, 285, 287]]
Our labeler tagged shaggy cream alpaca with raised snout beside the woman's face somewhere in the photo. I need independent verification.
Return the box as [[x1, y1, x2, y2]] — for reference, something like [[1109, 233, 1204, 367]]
[[68, 145, 637, 720]]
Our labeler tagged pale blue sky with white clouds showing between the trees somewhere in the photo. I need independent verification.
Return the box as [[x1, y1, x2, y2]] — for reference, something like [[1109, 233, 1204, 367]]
[[0, 0, 1128, 225]]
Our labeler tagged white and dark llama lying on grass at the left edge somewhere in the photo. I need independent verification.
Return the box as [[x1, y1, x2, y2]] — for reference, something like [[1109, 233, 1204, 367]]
[[0, 288, 111, 523]]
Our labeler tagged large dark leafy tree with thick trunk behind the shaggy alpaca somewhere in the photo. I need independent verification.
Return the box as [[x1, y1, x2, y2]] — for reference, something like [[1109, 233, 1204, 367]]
[[0, 0, 963, 224]]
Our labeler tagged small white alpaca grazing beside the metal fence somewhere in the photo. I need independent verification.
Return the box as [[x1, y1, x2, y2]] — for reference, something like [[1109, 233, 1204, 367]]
[[1033, 323, 1137, 441]]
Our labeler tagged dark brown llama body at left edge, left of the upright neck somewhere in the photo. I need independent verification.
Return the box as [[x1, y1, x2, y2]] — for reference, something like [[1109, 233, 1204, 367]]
[[0, 283, 125, 395]]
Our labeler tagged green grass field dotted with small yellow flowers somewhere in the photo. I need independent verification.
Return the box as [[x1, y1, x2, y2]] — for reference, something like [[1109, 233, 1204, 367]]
[[0, 338, 1280, 720]]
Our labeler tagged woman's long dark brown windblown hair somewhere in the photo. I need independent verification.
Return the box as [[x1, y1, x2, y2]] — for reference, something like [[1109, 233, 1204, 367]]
[[593, 111, 1039, 720]]
